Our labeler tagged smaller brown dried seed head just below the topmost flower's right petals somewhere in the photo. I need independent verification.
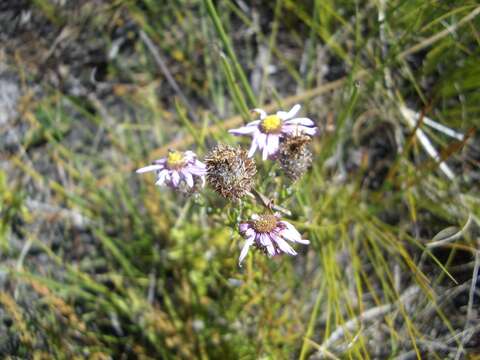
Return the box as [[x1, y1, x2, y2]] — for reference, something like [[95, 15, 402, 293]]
[[278, 135, 312, 181]]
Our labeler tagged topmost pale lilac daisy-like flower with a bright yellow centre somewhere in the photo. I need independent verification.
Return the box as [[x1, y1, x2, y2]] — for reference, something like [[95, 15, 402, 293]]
[[229, 104, 317, 160]]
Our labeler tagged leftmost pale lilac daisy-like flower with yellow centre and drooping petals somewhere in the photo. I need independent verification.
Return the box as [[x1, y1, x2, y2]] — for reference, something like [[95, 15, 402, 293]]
[[136, 150, 206, 190]]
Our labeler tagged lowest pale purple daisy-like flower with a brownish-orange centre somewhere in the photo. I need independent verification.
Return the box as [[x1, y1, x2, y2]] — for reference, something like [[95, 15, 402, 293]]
[[238, 214, 310, 266]]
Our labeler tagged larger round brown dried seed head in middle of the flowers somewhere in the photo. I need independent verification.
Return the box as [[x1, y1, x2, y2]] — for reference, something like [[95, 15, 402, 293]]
[[205, 144, 257, 200]]
